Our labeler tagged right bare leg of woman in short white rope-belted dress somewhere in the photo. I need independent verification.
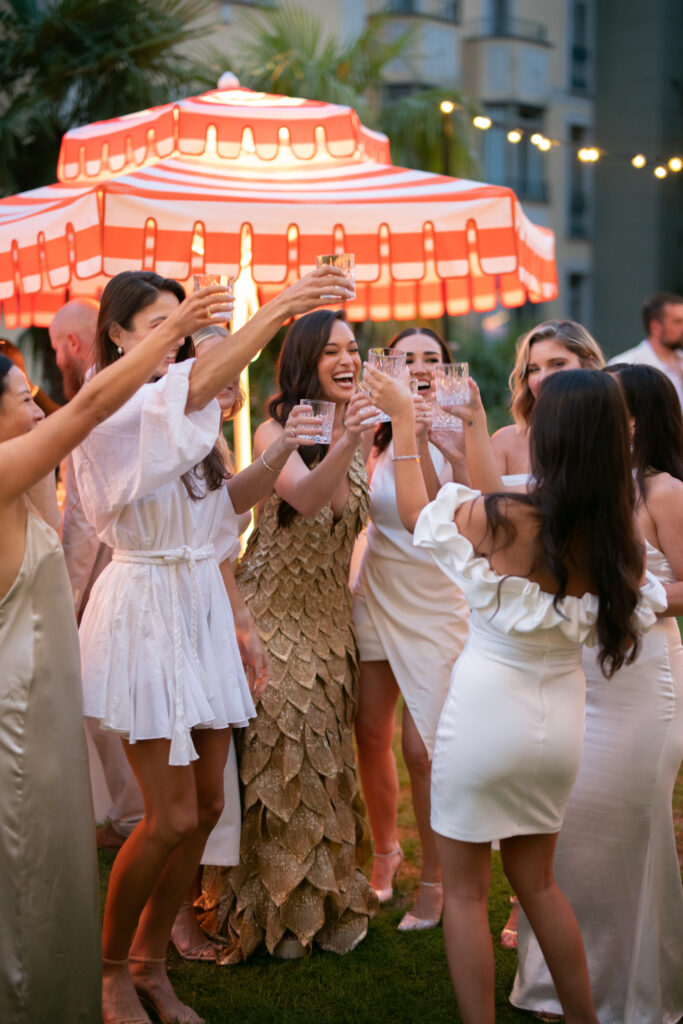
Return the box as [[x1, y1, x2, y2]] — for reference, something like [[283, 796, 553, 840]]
[[131, 729, 230, 1024]]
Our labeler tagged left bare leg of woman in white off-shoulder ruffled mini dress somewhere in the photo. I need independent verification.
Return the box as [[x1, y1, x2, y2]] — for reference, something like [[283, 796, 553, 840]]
[[436, 835, 496, 1024]]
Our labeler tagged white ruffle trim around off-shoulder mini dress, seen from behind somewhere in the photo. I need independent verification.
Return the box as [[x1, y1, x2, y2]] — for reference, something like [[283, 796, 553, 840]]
[[414, 483, 666, 645]]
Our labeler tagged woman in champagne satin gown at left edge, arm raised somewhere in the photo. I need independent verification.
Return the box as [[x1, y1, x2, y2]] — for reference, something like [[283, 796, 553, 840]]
[[0, 289, 228, 1024]]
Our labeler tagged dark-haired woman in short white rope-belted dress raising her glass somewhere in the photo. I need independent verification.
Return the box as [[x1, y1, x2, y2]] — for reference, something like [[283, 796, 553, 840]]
[[74, 270, 348, 1024]]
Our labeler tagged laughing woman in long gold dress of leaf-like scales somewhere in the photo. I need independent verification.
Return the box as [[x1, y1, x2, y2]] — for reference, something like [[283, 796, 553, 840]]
[[205, 310, 377, 963]]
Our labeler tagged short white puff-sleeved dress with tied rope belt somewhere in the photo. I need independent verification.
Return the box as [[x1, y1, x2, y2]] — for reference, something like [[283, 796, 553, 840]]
[[74, 360, 254, 765]]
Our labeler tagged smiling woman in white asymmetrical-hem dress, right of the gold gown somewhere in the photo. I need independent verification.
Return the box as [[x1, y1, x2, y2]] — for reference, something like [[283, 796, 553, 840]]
[[353, 327, 467, 931]]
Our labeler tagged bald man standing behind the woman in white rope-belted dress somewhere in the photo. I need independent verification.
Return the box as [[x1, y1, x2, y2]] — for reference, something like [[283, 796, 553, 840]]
[[49, 299, 143, 849]]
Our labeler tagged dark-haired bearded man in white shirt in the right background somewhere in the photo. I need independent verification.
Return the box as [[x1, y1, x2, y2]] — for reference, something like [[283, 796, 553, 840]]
[[609, 292, 683, 408]]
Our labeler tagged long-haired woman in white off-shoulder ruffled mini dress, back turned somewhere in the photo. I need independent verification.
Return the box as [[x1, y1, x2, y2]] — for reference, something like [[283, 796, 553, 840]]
[[366, 370, 661, 1024]]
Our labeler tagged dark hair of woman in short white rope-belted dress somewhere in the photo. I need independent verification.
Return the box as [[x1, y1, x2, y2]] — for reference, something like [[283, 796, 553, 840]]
[[94, 270, 226, 501]]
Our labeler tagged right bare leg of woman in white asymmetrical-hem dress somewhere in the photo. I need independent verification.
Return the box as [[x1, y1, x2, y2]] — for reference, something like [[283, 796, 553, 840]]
[[399, 705, 443, 927]]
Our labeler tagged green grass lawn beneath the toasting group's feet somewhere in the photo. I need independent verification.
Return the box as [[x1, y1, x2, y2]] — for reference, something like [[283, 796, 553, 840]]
[[99, 720, 683, 1024]]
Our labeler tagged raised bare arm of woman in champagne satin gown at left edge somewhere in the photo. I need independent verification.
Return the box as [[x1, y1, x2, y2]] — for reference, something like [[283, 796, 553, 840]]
[[0, 286, 229, 502]]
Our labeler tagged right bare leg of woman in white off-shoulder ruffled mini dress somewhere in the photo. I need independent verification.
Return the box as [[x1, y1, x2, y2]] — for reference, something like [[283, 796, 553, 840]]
[[501, 835, 598, 1024]]
